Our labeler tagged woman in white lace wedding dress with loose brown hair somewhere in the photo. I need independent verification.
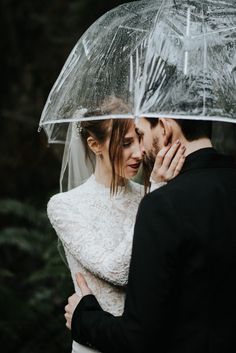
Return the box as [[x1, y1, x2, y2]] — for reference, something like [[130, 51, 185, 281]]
[[47, 99, 183, 353]]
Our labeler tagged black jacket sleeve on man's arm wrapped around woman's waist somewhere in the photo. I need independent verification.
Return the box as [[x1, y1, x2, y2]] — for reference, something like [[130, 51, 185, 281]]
[[73, 190, 182, 353]]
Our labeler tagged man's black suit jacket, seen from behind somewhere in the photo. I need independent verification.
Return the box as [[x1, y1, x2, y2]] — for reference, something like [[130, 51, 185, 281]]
[[72, 148, 236, 353]]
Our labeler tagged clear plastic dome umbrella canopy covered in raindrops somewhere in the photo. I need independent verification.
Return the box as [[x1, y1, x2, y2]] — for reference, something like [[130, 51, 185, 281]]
[[40, 0, 236, 142]]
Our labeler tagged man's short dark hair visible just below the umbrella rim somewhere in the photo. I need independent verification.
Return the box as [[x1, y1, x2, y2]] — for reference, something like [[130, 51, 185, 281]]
[[146, 118, 212, 141]]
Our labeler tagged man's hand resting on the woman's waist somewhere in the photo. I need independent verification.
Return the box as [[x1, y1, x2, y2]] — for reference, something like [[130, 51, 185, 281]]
[[64, 273, 92, 330]]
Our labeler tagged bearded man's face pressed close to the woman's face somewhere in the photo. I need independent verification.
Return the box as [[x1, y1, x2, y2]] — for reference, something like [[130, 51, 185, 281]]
[[136, 118, 164, 164]]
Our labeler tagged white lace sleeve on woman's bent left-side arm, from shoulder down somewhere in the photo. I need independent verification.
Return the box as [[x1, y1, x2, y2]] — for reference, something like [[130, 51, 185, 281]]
[[47, 194, 133, 286]]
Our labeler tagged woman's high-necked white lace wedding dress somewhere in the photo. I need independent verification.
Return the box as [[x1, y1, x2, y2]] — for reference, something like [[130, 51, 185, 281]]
[[48, 175, 147, 353]]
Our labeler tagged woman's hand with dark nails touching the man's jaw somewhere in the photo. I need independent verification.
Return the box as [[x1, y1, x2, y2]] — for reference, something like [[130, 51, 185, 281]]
[[151, 140, 186, 183]]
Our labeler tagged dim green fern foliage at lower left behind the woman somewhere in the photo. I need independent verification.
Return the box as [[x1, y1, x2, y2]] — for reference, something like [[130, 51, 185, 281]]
[[0, 199, 73, 353]]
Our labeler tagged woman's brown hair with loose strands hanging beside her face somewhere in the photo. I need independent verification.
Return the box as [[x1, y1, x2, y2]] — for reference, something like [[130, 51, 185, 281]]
[[79, 97, 133, 195]]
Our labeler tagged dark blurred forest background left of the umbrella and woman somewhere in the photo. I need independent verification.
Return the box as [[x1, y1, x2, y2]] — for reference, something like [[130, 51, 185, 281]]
[[0, 0, 134, 353]]
